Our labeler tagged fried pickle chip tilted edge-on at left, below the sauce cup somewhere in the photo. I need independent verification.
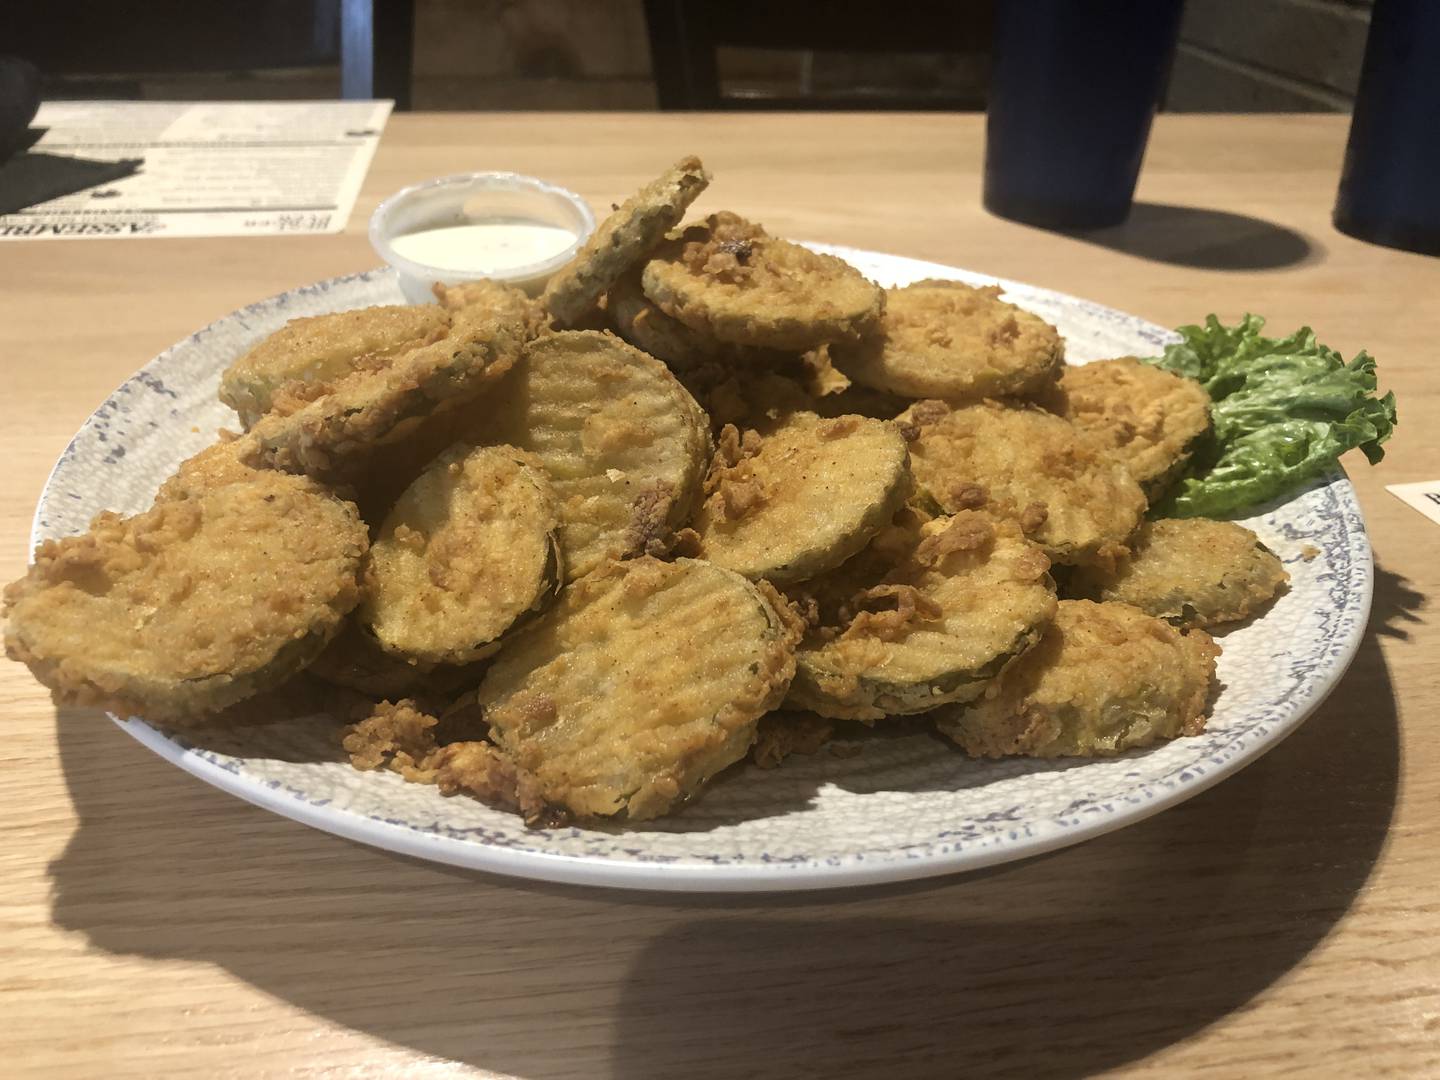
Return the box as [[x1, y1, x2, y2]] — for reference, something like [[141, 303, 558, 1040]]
[[242, 307, 530, 482]]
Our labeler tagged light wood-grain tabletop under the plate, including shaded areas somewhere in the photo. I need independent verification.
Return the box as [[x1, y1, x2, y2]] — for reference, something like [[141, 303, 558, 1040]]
[[0, 115, 1440, 1079]]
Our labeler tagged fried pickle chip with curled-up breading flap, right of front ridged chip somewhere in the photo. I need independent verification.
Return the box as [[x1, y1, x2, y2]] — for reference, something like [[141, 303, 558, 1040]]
[[788, 510, 1056, 720]]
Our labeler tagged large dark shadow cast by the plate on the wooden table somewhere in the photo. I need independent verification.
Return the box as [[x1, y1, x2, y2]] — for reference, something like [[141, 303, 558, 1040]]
[[52, 573, 1417, 1080]]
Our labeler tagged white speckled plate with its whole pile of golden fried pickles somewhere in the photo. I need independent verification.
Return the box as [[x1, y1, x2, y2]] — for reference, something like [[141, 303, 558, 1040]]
[[4, 158, 1392, 890]]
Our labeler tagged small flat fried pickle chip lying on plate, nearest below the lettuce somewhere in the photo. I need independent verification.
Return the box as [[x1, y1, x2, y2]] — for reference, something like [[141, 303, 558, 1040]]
[[1070, 517, 1290, 626]]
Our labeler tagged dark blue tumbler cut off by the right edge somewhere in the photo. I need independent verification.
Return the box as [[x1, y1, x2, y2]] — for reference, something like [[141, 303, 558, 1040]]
[[1335, 0, 1440, 255]]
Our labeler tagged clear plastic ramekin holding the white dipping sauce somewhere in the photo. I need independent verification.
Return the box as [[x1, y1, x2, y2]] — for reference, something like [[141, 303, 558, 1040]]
[[370, 173, 595, 304]]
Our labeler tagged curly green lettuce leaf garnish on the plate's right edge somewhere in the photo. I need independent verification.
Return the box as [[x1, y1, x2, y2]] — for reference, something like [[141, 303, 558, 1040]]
[[1146, 315, 1395, 517]]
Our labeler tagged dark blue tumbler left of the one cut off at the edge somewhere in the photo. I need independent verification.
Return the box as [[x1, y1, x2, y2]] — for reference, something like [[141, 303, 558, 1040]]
[[985, 0, 1184, 229]]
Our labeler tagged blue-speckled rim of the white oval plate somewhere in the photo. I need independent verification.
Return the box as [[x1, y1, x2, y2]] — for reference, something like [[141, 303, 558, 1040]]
[[30, 256, 1374, 893]]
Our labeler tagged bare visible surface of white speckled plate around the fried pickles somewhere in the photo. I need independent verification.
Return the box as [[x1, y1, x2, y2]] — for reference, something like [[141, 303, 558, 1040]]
[[33, 248, 1372, 891]]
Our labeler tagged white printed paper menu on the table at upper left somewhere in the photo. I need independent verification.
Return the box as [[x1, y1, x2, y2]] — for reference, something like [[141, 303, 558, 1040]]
[[0, 101, 395, 240]]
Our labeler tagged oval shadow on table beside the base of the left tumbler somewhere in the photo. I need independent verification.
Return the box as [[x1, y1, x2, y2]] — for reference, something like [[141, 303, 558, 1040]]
[[1063, 202, 1323, 271]]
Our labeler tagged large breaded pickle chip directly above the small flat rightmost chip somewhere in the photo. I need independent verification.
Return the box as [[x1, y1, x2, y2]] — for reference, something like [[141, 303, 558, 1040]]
[[897, 400, 1146, 563]]
